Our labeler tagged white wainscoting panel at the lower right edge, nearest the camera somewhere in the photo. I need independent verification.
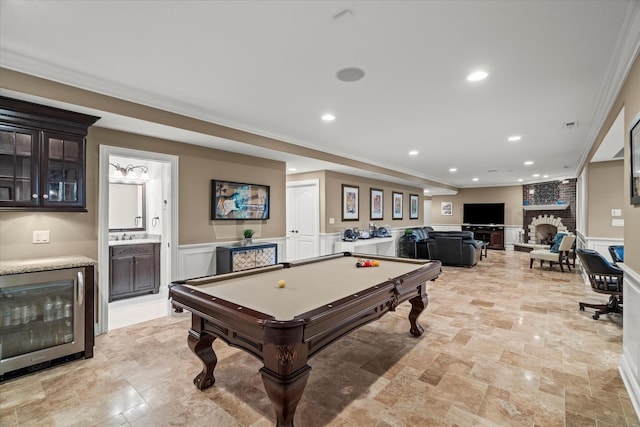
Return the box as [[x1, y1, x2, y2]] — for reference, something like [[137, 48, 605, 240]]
[[618, 264, 640, 418]]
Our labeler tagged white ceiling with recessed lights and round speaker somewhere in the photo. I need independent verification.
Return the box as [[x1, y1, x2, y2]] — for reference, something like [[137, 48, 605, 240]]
[[0, 0, 640, 194]]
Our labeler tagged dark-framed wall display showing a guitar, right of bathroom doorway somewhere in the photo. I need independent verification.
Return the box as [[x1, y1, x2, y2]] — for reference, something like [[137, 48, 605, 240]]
[[211, 179, 269, 220]]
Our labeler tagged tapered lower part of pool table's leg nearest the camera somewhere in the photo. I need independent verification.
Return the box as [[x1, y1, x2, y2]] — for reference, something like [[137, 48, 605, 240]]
[[260, 365, 311, 427]]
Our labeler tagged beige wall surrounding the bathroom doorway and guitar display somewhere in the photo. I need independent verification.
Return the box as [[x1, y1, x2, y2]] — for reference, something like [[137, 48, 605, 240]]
[[0, 126, 285, 260]]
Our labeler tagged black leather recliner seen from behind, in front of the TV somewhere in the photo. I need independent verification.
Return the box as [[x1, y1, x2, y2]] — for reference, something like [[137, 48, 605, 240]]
[[426, 231, 482, 267]]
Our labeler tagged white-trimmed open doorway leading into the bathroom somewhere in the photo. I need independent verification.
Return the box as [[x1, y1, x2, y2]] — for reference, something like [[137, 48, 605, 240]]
[[96, 145, 178, 334]]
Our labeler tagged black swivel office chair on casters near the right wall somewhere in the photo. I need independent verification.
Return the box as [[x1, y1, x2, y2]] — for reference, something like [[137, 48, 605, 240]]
[[576, 249, 623, 320]]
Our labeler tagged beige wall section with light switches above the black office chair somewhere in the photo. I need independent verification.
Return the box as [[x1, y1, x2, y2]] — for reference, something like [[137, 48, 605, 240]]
[[587, 160, 628, 239]]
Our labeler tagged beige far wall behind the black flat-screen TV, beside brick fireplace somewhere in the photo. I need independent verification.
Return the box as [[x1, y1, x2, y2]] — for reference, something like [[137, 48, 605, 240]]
[[431, 185, 522, 227]]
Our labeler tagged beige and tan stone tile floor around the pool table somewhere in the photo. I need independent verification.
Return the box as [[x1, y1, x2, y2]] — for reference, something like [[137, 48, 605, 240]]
[[0, 251, 640, 427]]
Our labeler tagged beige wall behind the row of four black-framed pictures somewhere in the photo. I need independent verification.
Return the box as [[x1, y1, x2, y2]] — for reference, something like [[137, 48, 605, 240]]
[[287, 171, 424, 233]]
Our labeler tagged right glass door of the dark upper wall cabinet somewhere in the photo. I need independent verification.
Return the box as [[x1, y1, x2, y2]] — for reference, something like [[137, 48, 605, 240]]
[[43, 133, 84, 206]]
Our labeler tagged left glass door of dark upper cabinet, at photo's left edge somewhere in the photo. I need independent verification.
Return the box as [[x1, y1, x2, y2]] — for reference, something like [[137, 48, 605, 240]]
[[0, 126, 39, 206]]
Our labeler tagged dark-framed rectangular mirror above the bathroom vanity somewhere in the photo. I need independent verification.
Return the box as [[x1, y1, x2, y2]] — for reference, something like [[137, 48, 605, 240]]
[[109, 182, 147, 231]]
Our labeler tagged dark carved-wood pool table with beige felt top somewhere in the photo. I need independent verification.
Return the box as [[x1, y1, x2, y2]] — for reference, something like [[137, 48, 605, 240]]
[[169, 252, 442, 426]]
